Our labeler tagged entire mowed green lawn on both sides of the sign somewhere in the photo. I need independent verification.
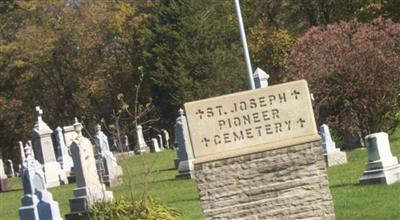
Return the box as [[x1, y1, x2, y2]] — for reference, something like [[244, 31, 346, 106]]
[[0, 130, 400, 220]]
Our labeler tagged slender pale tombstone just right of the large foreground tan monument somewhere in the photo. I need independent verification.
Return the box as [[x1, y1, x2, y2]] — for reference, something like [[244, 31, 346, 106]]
[[96, 125, 122, 186]]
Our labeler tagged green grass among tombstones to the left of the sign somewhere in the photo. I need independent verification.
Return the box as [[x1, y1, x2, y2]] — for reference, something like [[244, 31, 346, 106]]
[[0, 150, 202, 220]]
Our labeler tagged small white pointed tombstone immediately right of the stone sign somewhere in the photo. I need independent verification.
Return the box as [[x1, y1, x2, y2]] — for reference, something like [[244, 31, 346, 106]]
[[320, 124, 347, 167]]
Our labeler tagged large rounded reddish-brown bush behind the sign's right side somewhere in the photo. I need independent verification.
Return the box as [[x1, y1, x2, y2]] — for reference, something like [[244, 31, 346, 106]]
[[287, 18, 400, 144]]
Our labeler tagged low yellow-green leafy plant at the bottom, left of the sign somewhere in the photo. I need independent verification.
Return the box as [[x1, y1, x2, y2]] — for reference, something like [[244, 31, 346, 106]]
[[88, 197, 180, 220]]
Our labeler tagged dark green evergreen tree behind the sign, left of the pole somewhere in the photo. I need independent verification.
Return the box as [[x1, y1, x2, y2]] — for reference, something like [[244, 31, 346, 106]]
[[145, 0, 247, 126]]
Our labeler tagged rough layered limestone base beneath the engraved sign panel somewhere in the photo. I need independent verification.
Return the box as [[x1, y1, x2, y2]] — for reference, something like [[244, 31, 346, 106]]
[[195, 140, 335, 220]]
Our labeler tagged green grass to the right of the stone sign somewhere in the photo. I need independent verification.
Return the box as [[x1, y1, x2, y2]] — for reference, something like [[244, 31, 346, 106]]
[[328, 128, 400, 220]]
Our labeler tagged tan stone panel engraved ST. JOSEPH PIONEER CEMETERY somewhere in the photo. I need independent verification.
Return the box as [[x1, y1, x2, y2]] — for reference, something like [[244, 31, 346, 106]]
[[185, 80, 318, 159]]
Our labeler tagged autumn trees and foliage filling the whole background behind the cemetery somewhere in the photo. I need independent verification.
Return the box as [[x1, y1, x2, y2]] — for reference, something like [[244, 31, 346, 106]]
[[0, 0, 400, 160]]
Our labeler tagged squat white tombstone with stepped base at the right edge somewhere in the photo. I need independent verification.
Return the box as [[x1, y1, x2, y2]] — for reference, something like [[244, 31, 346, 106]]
[[360, 132, 400, 185]]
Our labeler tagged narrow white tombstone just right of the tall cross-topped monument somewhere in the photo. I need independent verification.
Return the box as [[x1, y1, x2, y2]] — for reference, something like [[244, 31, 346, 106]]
[[56, 127, 74, 176]]
